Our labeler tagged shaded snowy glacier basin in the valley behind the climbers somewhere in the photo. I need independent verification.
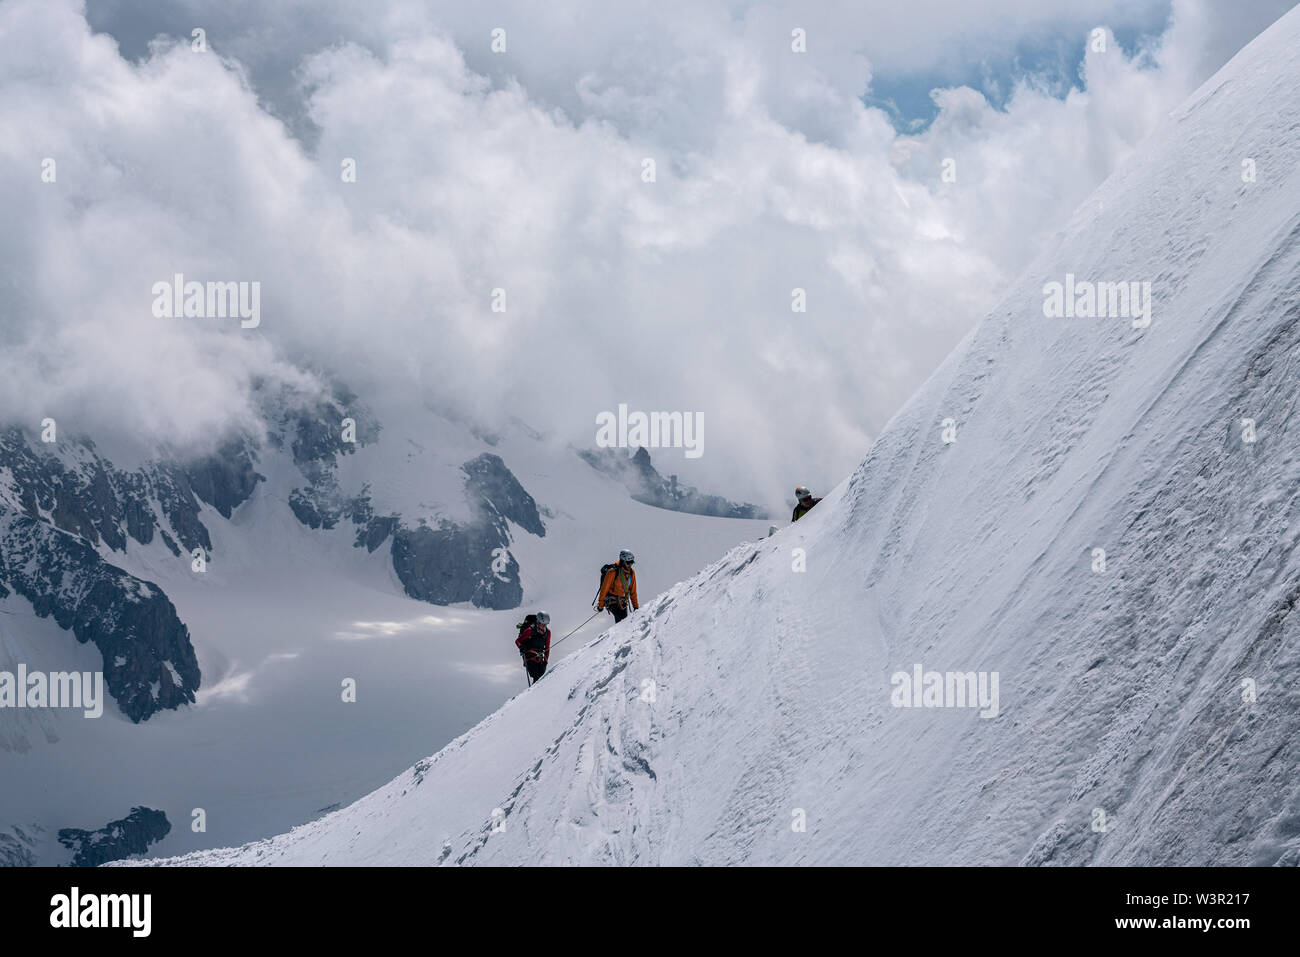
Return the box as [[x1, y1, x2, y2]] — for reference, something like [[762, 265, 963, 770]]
[[0, 400, 768, 863]]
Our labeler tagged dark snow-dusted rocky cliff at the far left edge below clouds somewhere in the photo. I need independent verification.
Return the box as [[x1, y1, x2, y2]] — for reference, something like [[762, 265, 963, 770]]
[[0, 428, 261, 722]]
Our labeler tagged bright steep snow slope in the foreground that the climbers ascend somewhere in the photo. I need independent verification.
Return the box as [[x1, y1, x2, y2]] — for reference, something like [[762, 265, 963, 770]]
[[147, 10, 1300, 865]]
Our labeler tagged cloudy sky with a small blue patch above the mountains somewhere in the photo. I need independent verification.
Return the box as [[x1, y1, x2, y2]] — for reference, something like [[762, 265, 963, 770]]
[[0, 0, 1294, 502]]
